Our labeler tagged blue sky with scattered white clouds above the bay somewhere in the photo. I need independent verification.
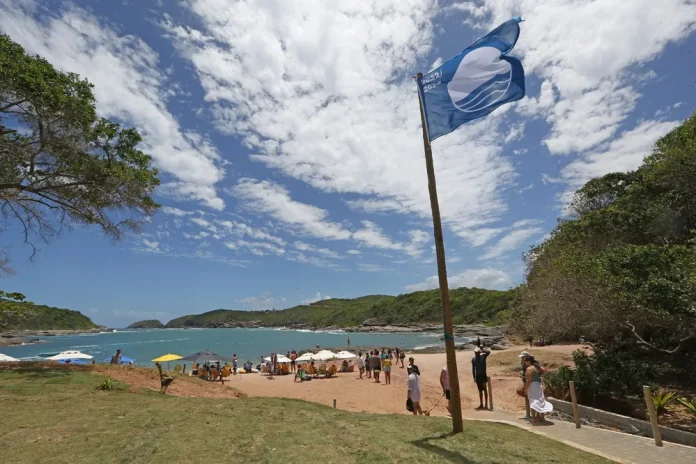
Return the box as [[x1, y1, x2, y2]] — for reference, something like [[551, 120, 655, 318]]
[[0, 0, 696, 327]]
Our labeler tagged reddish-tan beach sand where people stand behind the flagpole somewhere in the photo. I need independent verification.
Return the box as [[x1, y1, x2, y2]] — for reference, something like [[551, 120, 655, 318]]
[[223, 345, 589, 416]]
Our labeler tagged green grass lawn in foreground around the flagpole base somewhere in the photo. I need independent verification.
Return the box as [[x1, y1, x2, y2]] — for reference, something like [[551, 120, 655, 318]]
[[0, 367, 608, 464]]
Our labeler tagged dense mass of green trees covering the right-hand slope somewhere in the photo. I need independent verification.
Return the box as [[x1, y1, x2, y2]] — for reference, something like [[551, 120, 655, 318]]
[[515, 113, 696, 358]]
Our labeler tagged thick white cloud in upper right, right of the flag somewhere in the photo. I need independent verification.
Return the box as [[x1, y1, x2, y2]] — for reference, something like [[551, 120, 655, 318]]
[[479, 0, 696, 154]]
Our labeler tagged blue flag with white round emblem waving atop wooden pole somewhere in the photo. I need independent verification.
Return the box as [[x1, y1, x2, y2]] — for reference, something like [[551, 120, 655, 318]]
[[418, 17, 524, 142]]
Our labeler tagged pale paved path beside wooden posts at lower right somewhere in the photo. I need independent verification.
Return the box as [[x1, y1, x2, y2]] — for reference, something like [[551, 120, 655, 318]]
[[464, 410, 696, 464]]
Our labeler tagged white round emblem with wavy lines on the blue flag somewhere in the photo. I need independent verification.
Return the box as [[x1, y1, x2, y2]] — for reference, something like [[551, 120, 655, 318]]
[[447, 47, 512, 113]]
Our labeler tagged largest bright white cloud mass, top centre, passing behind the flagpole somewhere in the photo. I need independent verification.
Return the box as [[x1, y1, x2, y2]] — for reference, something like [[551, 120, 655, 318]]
[[163, 0, 514, 243]]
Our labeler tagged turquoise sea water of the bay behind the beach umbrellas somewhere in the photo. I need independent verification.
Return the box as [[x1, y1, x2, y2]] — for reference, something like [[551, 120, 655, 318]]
[[2, 328, 460, 366]]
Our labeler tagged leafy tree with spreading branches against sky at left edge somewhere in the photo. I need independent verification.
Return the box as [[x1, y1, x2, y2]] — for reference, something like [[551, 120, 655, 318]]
[[0, 35, 159, 271]]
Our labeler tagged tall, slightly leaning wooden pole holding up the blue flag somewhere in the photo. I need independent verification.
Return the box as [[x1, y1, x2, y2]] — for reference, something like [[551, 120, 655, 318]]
[[416, 73, 464, 433]]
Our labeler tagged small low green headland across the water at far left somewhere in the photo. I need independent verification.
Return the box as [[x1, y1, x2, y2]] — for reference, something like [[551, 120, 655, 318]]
[[0, 299, 97, 332]]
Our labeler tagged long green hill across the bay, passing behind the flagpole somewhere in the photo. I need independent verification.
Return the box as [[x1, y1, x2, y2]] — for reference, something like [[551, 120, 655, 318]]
[[166, 287, 514, 328]]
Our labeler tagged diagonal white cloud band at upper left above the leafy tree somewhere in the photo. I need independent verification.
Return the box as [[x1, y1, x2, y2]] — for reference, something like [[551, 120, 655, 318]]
[[0, 0, 224, 210]]
